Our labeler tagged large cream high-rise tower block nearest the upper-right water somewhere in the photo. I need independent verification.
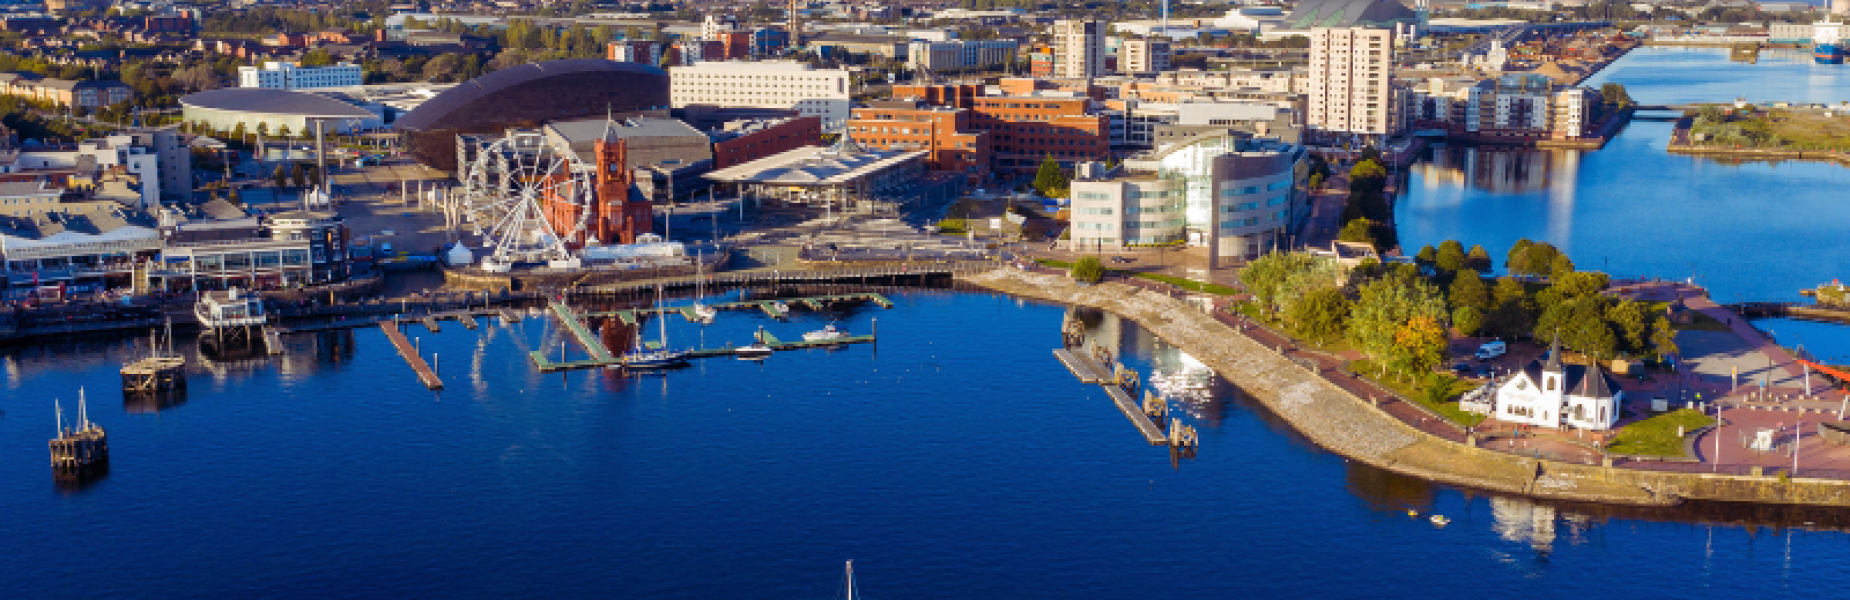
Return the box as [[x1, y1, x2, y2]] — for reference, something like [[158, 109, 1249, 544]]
[[1306, 28, 1400, 135]]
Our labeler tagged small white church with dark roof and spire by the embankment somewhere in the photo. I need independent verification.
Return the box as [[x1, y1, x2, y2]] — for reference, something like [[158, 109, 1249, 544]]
[[1460, 344, 1624, 431]]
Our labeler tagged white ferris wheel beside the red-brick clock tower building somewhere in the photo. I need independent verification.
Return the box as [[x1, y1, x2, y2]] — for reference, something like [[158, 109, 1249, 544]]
[[461, 131, 596, 270]]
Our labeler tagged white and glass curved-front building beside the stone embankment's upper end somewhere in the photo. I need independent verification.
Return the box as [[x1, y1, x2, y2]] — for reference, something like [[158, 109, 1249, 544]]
[[1069, 131, 1310, 259]]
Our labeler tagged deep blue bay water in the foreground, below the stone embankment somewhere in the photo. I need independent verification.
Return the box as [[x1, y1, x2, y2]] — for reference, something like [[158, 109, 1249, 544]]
[[0, 291, 1850, 598]]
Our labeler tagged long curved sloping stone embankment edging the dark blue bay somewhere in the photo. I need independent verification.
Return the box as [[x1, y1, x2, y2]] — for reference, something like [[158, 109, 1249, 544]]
[[960, 269, 1850, 506]]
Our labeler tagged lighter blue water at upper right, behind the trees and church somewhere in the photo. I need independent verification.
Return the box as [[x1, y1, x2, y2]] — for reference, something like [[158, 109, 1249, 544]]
[[1397, 48, 1850, 305]]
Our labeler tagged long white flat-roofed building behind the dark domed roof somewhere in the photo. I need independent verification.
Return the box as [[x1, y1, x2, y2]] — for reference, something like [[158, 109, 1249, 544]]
[[668, 61, 851, 131]]
